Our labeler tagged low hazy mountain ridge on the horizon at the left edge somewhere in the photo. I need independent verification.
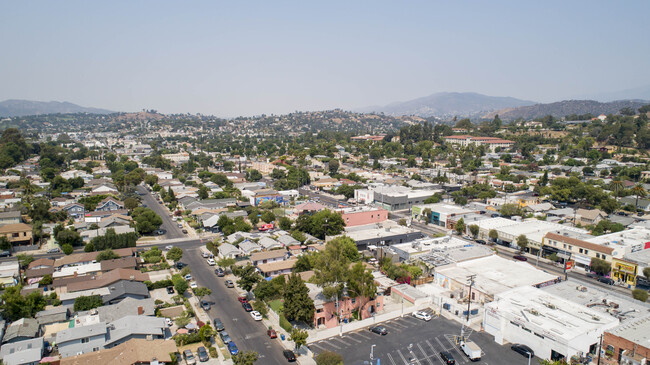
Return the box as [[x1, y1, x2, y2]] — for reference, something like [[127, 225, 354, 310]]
[[0, 100, 114, 117]]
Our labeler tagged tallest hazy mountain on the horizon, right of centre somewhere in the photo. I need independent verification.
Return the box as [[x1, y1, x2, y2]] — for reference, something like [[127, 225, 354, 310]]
[[359, 92, 535, 117]]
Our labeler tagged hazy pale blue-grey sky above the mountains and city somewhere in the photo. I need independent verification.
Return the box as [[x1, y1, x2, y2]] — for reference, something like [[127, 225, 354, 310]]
[[0, 0, 650, 117]]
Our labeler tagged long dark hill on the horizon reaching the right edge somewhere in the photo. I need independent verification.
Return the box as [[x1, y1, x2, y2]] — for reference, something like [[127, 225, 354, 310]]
[[483, 100, 650, 120]]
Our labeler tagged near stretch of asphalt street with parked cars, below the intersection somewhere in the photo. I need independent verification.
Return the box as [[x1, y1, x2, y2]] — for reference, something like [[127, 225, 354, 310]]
[[181, 246, 287, 364]]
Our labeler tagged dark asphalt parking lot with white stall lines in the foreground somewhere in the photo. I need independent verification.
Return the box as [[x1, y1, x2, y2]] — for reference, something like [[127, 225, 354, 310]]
[[309, 308, 537, 365]]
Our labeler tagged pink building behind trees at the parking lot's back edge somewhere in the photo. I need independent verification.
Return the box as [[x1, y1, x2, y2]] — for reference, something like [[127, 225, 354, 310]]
[[307, 283, 384, 328]]
